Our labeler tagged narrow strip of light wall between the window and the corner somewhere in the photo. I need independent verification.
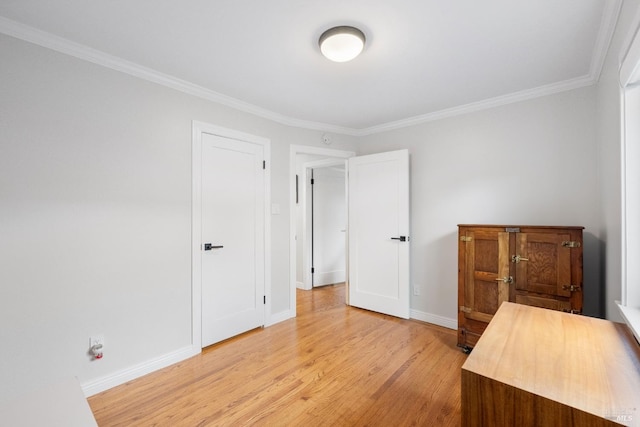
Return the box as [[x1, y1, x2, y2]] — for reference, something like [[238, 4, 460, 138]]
[[597, 0, 640, 321]]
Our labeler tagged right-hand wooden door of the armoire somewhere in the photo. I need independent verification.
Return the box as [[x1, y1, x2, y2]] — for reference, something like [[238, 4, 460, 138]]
[[511, 232, 571, 300]]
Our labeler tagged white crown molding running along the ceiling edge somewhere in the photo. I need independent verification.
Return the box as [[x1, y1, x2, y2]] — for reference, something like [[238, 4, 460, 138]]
[[0, 5, 622, 137]]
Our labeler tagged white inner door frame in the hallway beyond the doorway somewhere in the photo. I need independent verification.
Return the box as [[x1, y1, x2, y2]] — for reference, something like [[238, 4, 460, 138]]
[[296, 157, 347, 290]]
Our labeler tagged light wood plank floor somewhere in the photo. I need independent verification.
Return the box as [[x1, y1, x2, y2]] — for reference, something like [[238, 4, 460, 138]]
[[89, 285, 466, 427]]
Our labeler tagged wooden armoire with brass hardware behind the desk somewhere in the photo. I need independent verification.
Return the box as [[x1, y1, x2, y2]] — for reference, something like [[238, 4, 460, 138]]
[[458, 224, 584, 351]]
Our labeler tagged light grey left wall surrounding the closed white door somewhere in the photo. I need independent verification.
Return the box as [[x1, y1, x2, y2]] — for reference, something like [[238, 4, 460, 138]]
[[0, 35, 355, 401]]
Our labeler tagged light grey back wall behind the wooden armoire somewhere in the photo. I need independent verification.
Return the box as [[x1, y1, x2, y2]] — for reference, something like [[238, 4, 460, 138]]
[[360, 87, 601, 325]]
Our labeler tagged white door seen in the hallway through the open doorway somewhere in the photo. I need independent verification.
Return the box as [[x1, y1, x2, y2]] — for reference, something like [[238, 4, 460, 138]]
[[312, 165, 347, 286]]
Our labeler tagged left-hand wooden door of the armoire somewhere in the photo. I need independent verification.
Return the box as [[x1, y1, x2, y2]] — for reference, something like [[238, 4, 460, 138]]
[[460, 229, 510, 322]]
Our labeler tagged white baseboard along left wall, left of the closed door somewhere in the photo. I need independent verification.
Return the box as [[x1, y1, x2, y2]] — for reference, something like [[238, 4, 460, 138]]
[[82, 346, 202, 397]]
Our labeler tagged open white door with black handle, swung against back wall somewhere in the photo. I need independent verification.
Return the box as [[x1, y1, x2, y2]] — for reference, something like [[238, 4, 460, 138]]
[[348, 150, 410, 319]]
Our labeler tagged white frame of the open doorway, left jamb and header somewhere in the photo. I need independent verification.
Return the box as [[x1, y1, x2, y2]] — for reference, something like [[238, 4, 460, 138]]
[[289, 144, 356, 317]]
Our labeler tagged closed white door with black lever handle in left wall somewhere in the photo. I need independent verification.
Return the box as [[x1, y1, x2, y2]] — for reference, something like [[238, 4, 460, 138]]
[[201, 133, 265, 347]]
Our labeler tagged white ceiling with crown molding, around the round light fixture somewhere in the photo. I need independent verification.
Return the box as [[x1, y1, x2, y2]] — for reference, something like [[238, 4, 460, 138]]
[[0, 0, 620, 135]]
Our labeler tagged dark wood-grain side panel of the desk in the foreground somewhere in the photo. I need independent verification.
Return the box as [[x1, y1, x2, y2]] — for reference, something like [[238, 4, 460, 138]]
[[461, 369, 619, 427]]
